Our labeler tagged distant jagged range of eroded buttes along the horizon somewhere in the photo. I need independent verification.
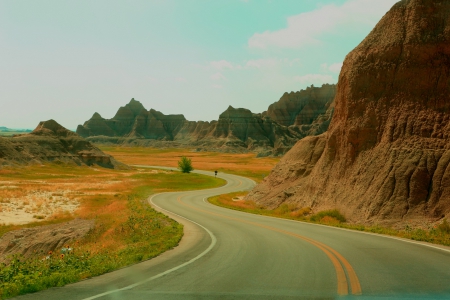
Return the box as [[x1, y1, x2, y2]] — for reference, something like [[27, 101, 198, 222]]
[[77, 84, 336, 155]]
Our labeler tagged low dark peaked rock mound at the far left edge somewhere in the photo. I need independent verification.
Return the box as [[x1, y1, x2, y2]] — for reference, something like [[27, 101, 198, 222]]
[[0, 120, 126, 168]]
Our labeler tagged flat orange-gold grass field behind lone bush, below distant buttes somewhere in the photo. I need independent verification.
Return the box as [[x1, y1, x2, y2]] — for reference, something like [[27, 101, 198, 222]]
[[100, 146, 280, 182]]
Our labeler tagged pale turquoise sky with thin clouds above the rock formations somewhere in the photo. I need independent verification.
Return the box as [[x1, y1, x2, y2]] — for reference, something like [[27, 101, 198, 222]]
[[0, 0, 397, 129]]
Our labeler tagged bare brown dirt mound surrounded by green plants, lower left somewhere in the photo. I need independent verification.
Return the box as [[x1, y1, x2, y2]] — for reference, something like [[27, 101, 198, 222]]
[[0, 219, 95, 263]]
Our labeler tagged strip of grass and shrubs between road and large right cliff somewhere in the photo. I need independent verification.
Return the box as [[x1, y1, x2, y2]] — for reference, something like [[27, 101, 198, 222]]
[[208, 192, 450, 246]]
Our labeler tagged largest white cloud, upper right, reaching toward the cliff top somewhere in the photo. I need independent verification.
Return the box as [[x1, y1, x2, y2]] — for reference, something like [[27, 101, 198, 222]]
[[248, 0, 398, 49]]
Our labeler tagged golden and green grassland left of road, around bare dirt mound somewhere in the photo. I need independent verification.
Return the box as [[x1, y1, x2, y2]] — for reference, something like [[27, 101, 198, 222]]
[[0, 164, 225, 299]]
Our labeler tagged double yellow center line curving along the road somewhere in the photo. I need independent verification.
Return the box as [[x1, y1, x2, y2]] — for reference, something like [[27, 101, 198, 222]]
[[177, 196, 362, 296]]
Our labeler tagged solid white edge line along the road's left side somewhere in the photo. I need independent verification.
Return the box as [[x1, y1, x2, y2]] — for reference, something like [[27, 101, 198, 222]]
[[83, 193, 217, 300]]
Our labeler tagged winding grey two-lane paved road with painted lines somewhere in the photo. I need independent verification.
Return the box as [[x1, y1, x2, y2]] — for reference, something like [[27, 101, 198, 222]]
[[14, 171, 450, 300]]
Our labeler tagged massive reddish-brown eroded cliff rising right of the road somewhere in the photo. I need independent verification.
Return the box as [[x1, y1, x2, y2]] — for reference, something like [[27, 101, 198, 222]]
[[248, 0, 450, 224]]
